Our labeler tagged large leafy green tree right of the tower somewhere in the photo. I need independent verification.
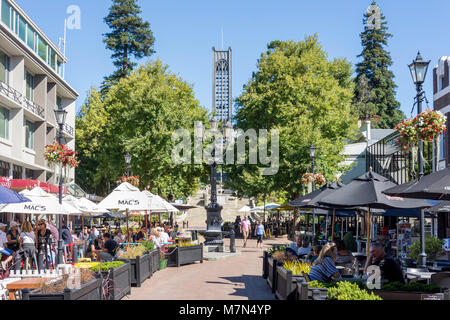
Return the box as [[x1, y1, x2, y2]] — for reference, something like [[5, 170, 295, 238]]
[[228, 35, 356, 198]]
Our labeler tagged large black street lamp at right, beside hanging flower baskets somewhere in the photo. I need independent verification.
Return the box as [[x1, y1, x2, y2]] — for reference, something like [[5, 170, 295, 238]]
[[408, 52, 431, 268]]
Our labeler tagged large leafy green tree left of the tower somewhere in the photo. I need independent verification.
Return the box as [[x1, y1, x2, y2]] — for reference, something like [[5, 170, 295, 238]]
[[77, 60, 208, 197]]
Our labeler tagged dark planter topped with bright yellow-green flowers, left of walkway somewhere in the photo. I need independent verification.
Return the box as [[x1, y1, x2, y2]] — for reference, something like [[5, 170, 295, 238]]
[[90, 261, 131, 300]]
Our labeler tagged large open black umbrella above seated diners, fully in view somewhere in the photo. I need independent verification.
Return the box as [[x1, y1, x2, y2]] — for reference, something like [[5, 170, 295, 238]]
[[319, 171, 430, 254]]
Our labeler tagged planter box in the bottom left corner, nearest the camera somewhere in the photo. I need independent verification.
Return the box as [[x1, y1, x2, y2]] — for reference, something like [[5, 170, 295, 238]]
[[22, 269, 102, 300]]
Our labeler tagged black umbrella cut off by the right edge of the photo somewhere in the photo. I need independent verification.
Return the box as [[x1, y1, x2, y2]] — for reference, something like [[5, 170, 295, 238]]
[[384, 167, 450, 200]]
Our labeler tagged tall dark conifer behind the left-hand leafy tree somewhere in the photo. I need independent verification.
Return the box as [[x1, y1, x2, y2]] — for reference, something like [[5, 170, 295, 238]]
[[102, 0, 155, 94]]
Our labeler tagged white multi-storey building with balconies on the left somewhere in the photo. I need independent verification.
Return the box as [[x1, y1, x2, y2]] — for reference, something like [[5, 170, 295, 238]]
[[0, 0, 78, 189]]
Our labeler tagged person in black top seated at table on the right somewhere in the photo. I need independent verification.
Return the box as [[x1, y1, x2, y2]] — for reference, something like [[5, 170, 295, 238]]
[[364, 242, 405, 283]]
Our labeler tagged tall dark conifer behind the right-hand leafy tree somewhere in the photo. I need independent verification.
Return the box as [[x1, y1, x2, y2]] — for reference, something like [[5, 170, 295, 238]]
[[354, 1, 405, 129]]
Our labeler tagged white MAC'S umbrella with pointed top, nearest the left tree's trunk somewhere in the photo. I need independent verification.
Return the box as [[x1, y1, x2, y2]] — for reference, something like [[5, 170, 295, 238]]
[[98, 182, 150, 244]]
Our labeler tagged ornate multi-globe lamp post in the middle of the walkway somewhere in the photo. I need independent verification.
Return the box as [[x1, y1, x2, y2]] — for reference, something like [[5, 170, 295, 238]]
[[195, 118, 233, 246]]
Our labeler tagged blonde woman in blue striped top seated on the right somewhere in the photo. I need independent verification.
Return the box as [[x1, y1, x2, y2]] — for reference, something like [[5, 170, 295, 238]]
[[309, 243, 341, 282]]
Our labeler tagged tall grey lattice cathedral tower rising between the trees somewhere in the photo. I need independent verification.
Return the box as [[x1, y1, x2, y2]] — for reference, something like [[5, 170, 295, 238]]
[[212, 47, 233, 122]]
